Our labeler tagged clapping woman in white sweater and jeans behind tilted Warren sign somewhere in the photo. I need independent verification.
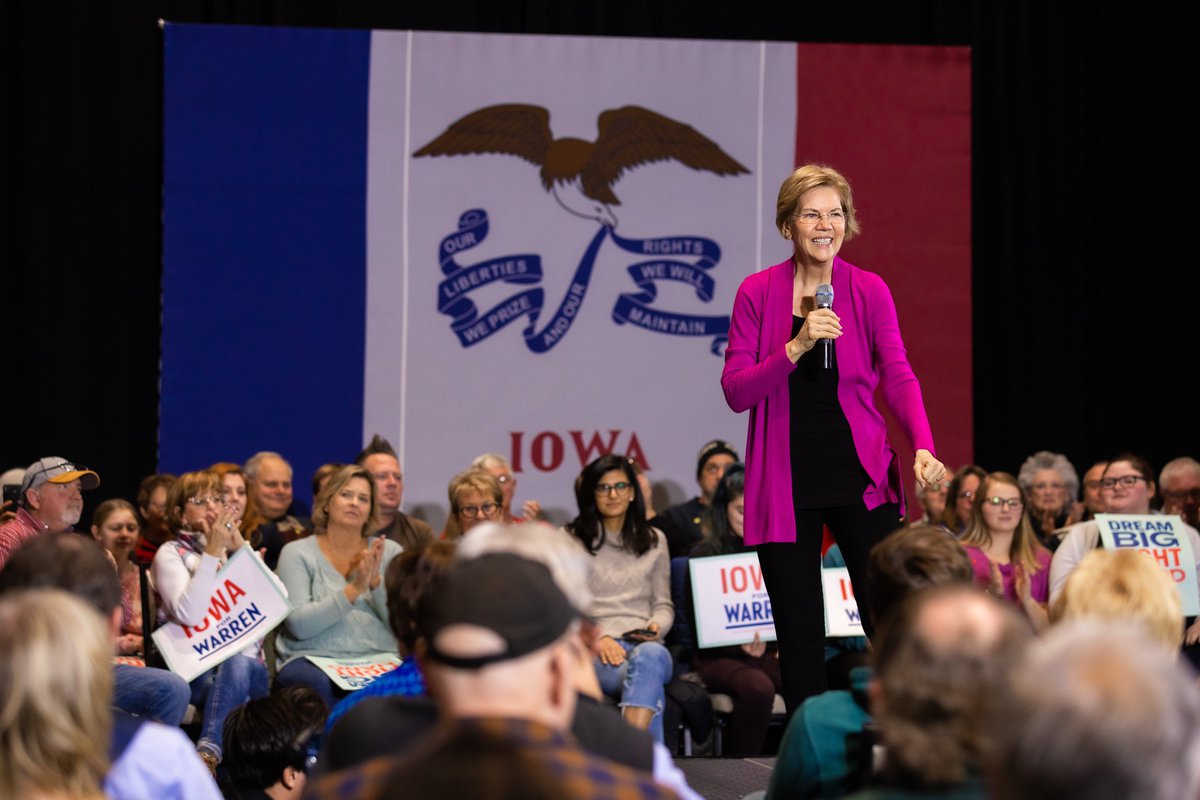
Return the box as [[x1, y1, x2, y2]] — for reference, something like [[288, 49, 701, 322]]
[[152, 470, 269, 771]]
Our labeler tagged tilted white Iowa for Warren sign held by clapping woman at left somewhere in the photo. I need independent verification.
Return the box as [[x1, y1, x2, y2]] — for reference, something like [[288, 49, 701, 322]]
[[154, 547, 292, 681]]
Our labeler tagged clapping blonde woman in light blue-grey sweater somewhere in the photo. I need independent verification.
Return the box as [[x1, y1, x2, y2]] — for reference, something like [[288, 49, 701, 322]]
[[276, 465, 401, 708]]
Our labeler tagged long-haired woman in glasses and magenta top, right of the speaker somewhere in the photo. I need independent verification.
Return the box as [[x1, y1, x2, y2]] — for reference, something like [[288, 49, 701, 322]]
[[961, 473, 1050, 630]]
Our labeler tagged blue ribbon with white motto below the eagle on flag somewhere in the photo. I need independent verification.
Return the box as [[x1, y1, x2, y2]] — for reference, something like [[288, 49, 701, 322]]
[[438, 209, 730, 355]]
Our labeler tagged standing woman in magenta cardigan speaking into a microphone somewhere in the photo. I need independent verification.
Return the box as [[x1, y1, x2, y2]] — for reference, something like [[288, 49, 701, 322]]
[[721, 164, 946, 712]]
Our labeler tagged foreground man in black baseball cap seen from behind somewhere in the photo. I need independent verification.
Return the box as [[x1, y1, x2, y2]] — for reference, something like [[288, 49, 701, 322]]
[[312, 553, 677, 800]]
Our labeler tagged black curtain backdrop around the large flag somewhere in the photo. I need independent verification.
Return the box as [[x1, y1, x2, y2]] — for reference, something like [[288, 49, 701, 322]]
[[0, 0, 1200, 506]]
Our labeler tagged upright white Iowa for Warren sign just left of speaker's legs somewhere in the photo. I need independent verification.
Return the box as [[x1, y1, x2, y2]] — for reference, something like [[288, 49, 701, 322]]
[[688, 552, 775, 648]]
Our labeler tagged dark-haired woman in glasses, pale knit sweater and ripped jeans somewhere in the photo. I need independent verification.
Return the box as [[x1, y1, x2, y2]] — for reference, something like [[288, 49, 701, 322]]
[[566, 455, 674, 742]]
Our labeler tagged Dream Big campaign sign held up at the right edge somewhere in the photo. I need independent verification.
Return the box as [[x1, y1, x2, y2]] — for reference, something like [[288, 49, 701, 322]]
[[1096, 513, 1200, 616]]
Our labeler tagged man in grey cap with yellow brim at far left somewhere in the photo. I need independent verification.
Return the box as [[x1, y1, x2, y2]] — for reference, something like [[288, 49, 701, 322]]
[[0, 456, 100, 570]]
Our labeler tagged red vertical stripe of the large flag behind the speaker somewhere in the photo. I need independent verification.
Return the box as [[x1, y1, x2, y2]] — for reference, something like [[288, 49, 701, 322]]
[[796, 44, 973, 515]]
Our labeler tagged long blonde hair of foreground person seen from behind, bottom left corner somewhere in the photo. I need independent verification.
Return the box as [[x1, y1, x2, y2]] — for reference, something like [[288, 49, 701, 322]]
[[0, 589, 113, 800]]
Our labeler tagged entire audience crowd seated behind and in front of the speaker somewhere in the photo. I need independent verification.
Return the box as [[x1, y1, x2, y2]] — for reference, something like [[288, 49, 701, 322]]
[[0, 437, 1200, 798]]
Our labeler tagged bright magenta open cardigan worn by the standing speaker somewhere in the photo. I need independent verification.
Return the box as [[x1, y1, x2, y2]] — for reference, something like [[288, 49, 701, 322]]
[[721, 258, 935, 545]]
